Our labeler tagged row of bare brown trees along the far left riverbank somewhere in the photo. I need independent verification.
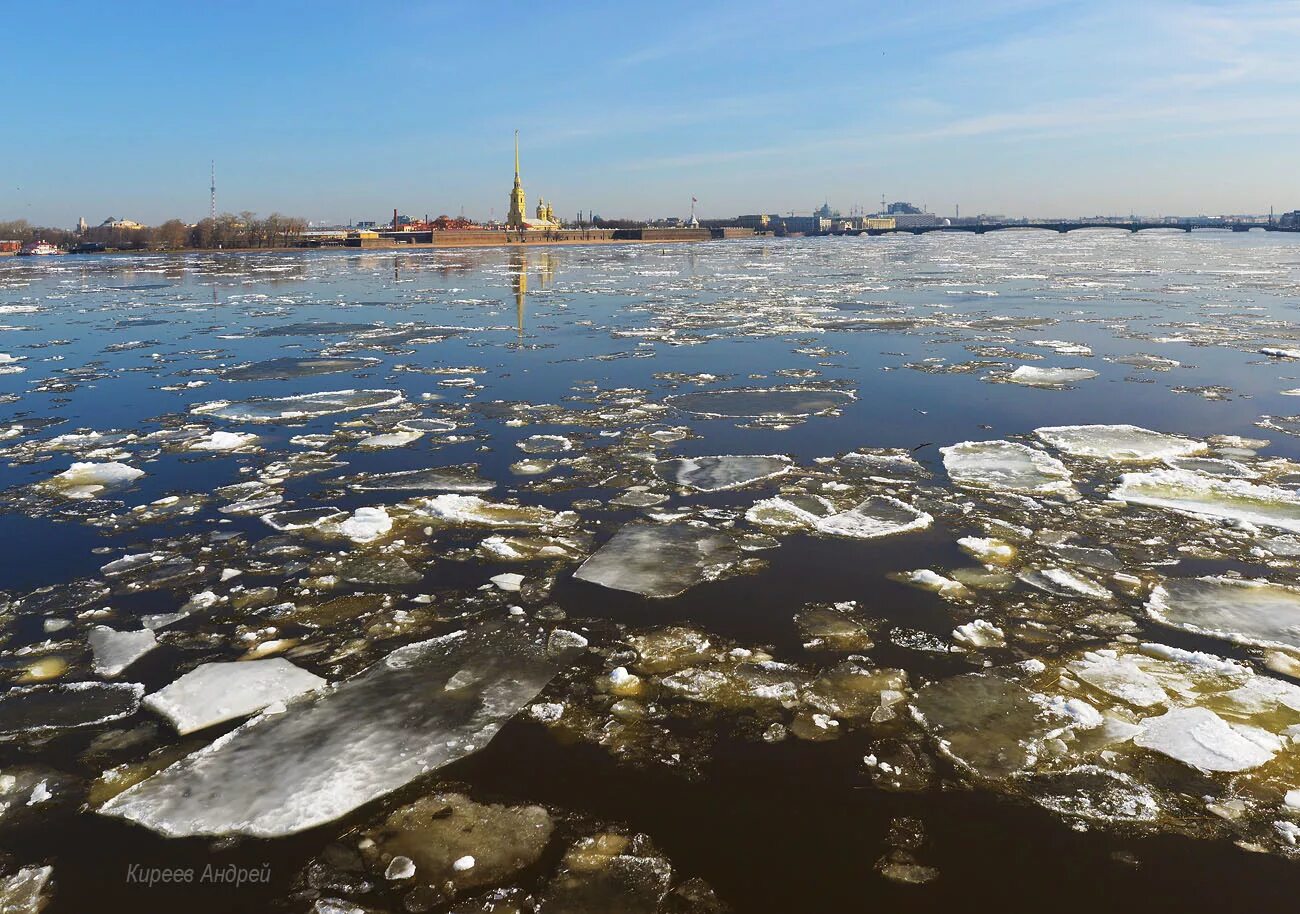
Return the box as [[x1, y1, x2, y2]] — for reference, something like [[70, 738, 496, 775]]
[[0, 211, 307, 251]]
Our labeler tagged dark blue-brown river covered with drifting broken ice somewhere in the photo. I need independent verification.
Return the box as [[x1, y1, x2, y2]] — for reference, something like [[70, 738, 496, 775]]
[[0, 230, 1300, 914]]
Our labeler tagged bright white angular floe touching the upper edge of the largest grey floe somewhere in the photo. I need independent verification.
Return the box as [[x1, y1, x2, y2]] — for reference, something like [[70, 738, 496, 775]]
[[144, 657, 328, 736]]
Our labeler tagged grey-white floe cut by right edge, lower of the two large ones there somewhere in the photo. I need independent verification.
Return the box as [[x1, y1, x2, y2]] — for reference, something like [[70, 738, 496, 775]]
[[1147, 577, 1300, 649]]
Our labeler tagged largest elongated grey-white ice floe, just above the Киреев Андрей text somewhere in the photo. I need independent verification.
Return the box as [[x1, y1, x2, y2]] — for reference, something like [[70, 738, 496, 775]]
[[99, 624, 582, 837]]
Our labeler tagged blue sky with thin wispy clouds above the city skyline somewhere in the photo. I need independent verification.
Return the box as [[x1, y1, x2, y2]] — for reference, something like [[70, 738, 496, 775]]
[[0, 0, 1300, 225]]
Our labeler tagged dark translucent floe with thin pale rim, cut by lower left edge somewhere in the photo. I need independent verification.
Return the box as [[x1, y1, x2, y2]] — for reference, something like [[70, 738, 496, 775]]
[[0, 683, 144, 736]]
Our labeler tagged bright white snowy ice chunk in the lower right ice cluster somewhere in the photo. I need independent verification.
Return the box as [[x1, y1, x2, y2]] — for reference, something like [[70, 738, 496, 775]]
[[1134, 707, 1282, 771]]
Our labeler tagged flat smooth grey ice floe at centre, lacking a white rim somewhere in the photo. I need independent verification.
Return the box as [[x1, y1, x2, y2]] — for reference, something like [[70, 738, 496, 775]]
[[573, 521, 740, 597]]
